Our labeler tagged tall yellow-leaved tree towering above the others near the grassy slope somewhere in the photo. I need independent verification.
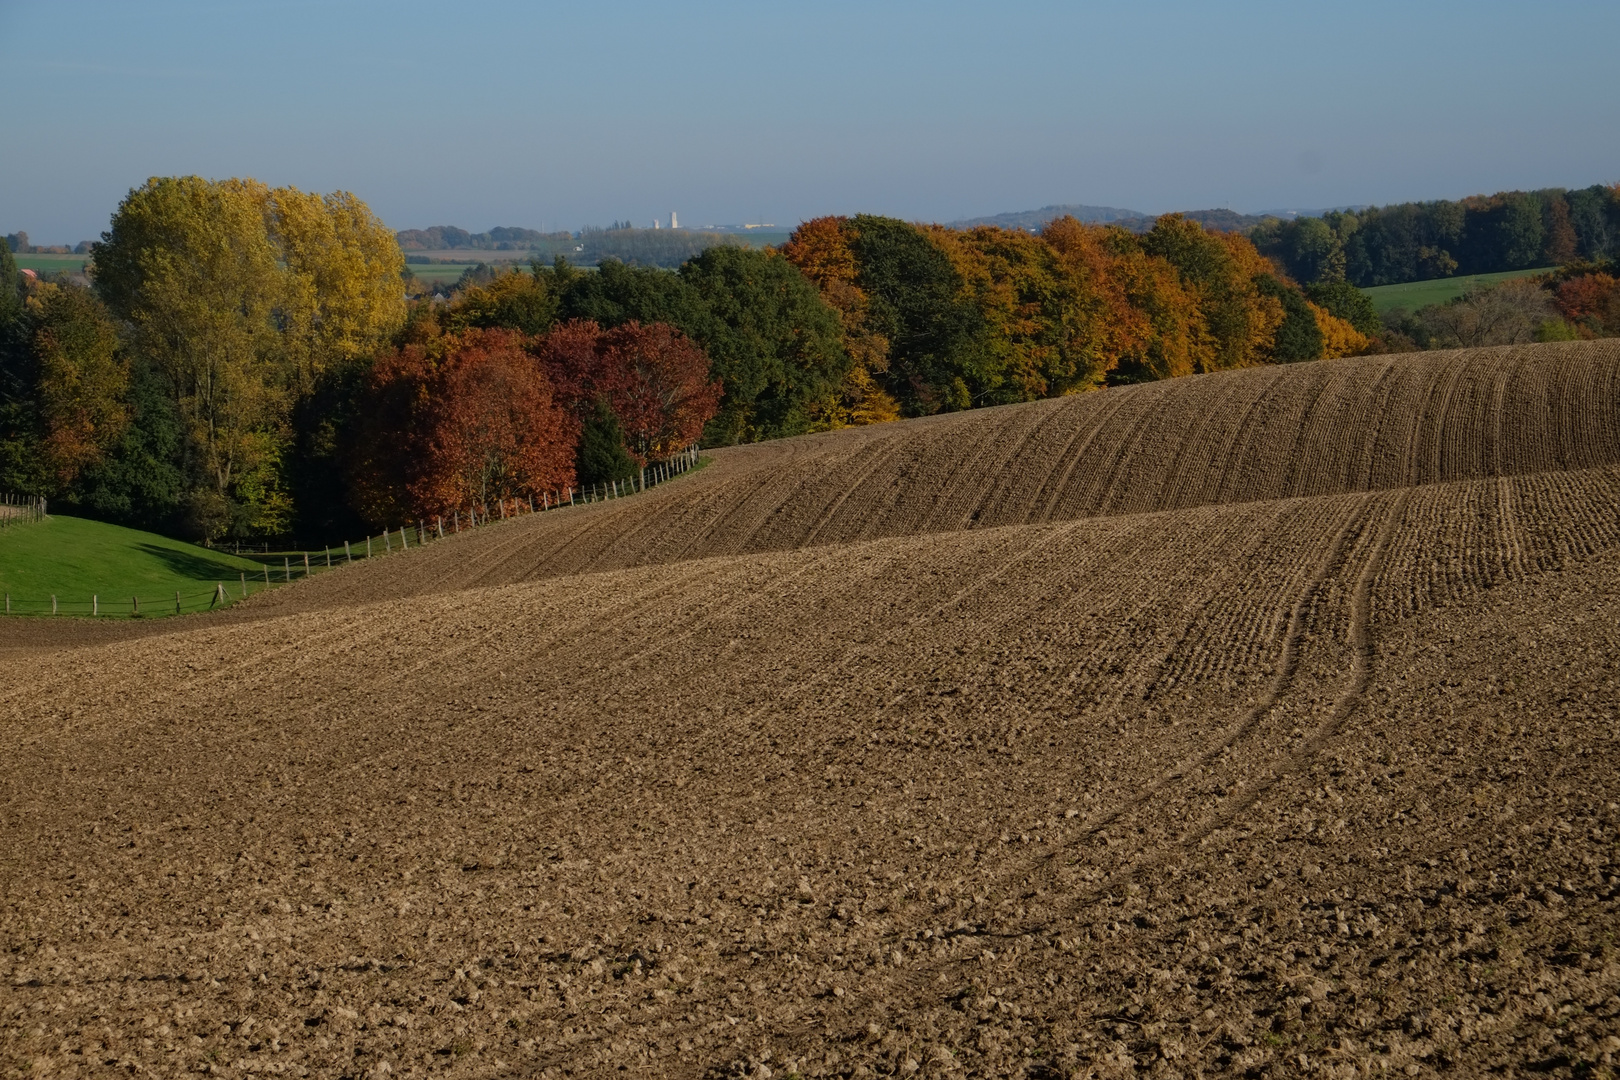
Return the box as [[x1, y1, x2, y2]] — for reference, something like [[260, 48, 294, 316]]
[[91, 176, 405, 539]]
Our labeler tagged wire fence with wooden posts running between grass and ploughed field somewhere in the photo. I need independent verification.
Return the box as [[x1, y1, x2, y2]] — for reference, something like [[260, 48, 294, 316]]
[[3, 445, 700, 619]]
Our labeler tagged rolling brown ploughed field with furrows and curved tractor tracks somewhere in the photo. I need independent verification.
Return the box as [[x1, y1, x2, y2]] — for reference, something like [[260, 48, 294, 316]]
[[0, 345, 1620, 1077]]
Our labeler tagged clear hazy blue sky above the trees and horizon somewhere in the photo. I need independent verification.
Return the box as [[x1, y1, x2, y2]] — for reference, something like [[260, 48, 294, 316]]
[[0, 0, 1620, 243]]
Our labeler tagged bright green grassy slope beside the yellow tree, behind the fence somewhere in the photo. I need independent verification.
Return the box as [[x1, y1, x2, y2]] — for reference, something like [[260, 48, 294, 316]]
[[0, 515, 262, 614]]
